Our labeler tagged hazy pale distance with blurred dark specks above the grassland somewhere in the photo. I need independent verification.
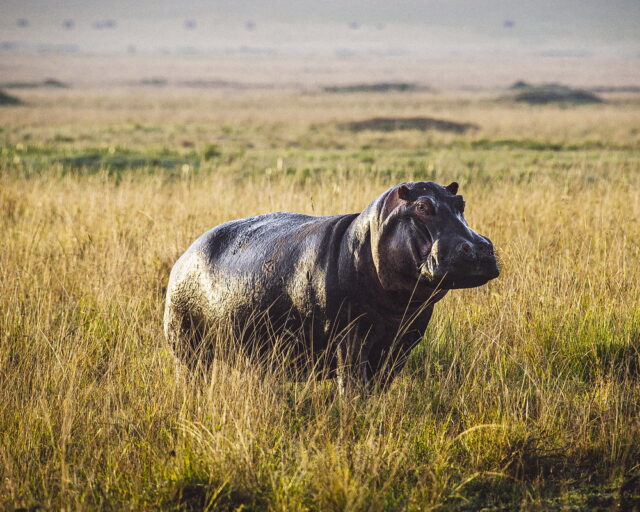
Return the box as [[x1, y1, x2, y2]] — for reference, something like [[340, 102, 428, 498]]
[[0, 0, 640, 89]]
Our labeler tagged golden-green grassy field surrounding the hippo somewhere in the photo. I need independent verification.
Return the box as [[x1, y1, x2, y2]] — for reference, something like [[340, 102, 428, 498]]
[[0, 89, 640, 511]]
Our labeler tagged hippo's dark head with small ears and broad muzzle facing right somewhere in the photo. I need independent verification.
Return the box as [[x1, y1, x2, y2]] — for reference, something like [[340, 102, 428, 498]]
[[372, 181, 499, 290]]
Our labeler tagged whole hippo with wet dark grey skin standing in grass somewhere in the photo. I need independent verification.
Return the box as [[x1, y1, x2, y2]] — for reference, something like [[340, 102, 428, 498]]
[[164, 181, 499, 387]]
